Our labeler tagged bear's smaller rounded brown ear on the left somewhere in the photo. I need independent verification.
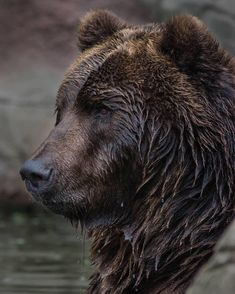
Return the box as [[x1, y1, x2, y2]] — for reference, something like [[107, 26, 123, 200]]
[[78, 10, 127, 51]]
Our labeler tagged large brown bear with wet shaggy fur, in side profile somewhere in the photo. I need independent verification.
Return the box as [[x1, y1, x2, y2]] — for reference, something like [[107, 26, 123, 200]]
[[21, 11, 235, 294]]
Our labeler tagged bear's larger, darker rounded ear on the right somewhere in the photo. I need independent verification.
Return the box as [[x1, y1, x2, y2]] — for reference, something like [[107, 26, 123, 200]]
[[160, 15, 224, 73]]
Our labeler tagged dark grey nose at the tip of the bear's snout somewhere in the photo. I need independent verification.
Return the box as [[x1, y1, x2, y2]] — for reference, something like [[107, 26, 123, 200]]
[[20, 159, 53, 192]]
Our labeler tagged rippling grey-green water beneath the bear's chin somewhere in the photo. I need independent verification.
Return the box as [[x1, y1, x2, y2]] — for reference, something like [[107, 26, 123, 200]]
[[0, 210, 92, 294]]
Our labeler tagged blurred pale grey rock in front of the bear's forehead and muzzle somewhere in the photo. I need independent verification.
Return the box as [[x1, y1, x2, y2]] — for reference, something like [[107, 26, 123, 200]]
[[0, 66, 59, 200]]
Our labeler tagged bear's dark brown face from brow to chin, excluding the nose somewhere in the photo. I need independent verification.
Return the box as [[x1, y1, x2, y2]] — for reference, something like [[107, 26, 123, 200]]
[[29, 57, 144, 225]]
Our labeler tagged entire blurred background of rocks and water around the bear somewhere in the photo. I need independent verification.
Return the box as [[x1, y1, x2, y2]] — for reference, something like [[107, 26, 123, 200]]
[[0, 0, 235, 294]]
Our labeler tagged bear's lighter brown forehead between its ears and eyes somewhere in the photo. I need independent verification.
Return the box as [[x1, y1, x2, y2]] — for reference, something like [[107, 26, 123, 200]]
[[57, 27, 179, 106]]
